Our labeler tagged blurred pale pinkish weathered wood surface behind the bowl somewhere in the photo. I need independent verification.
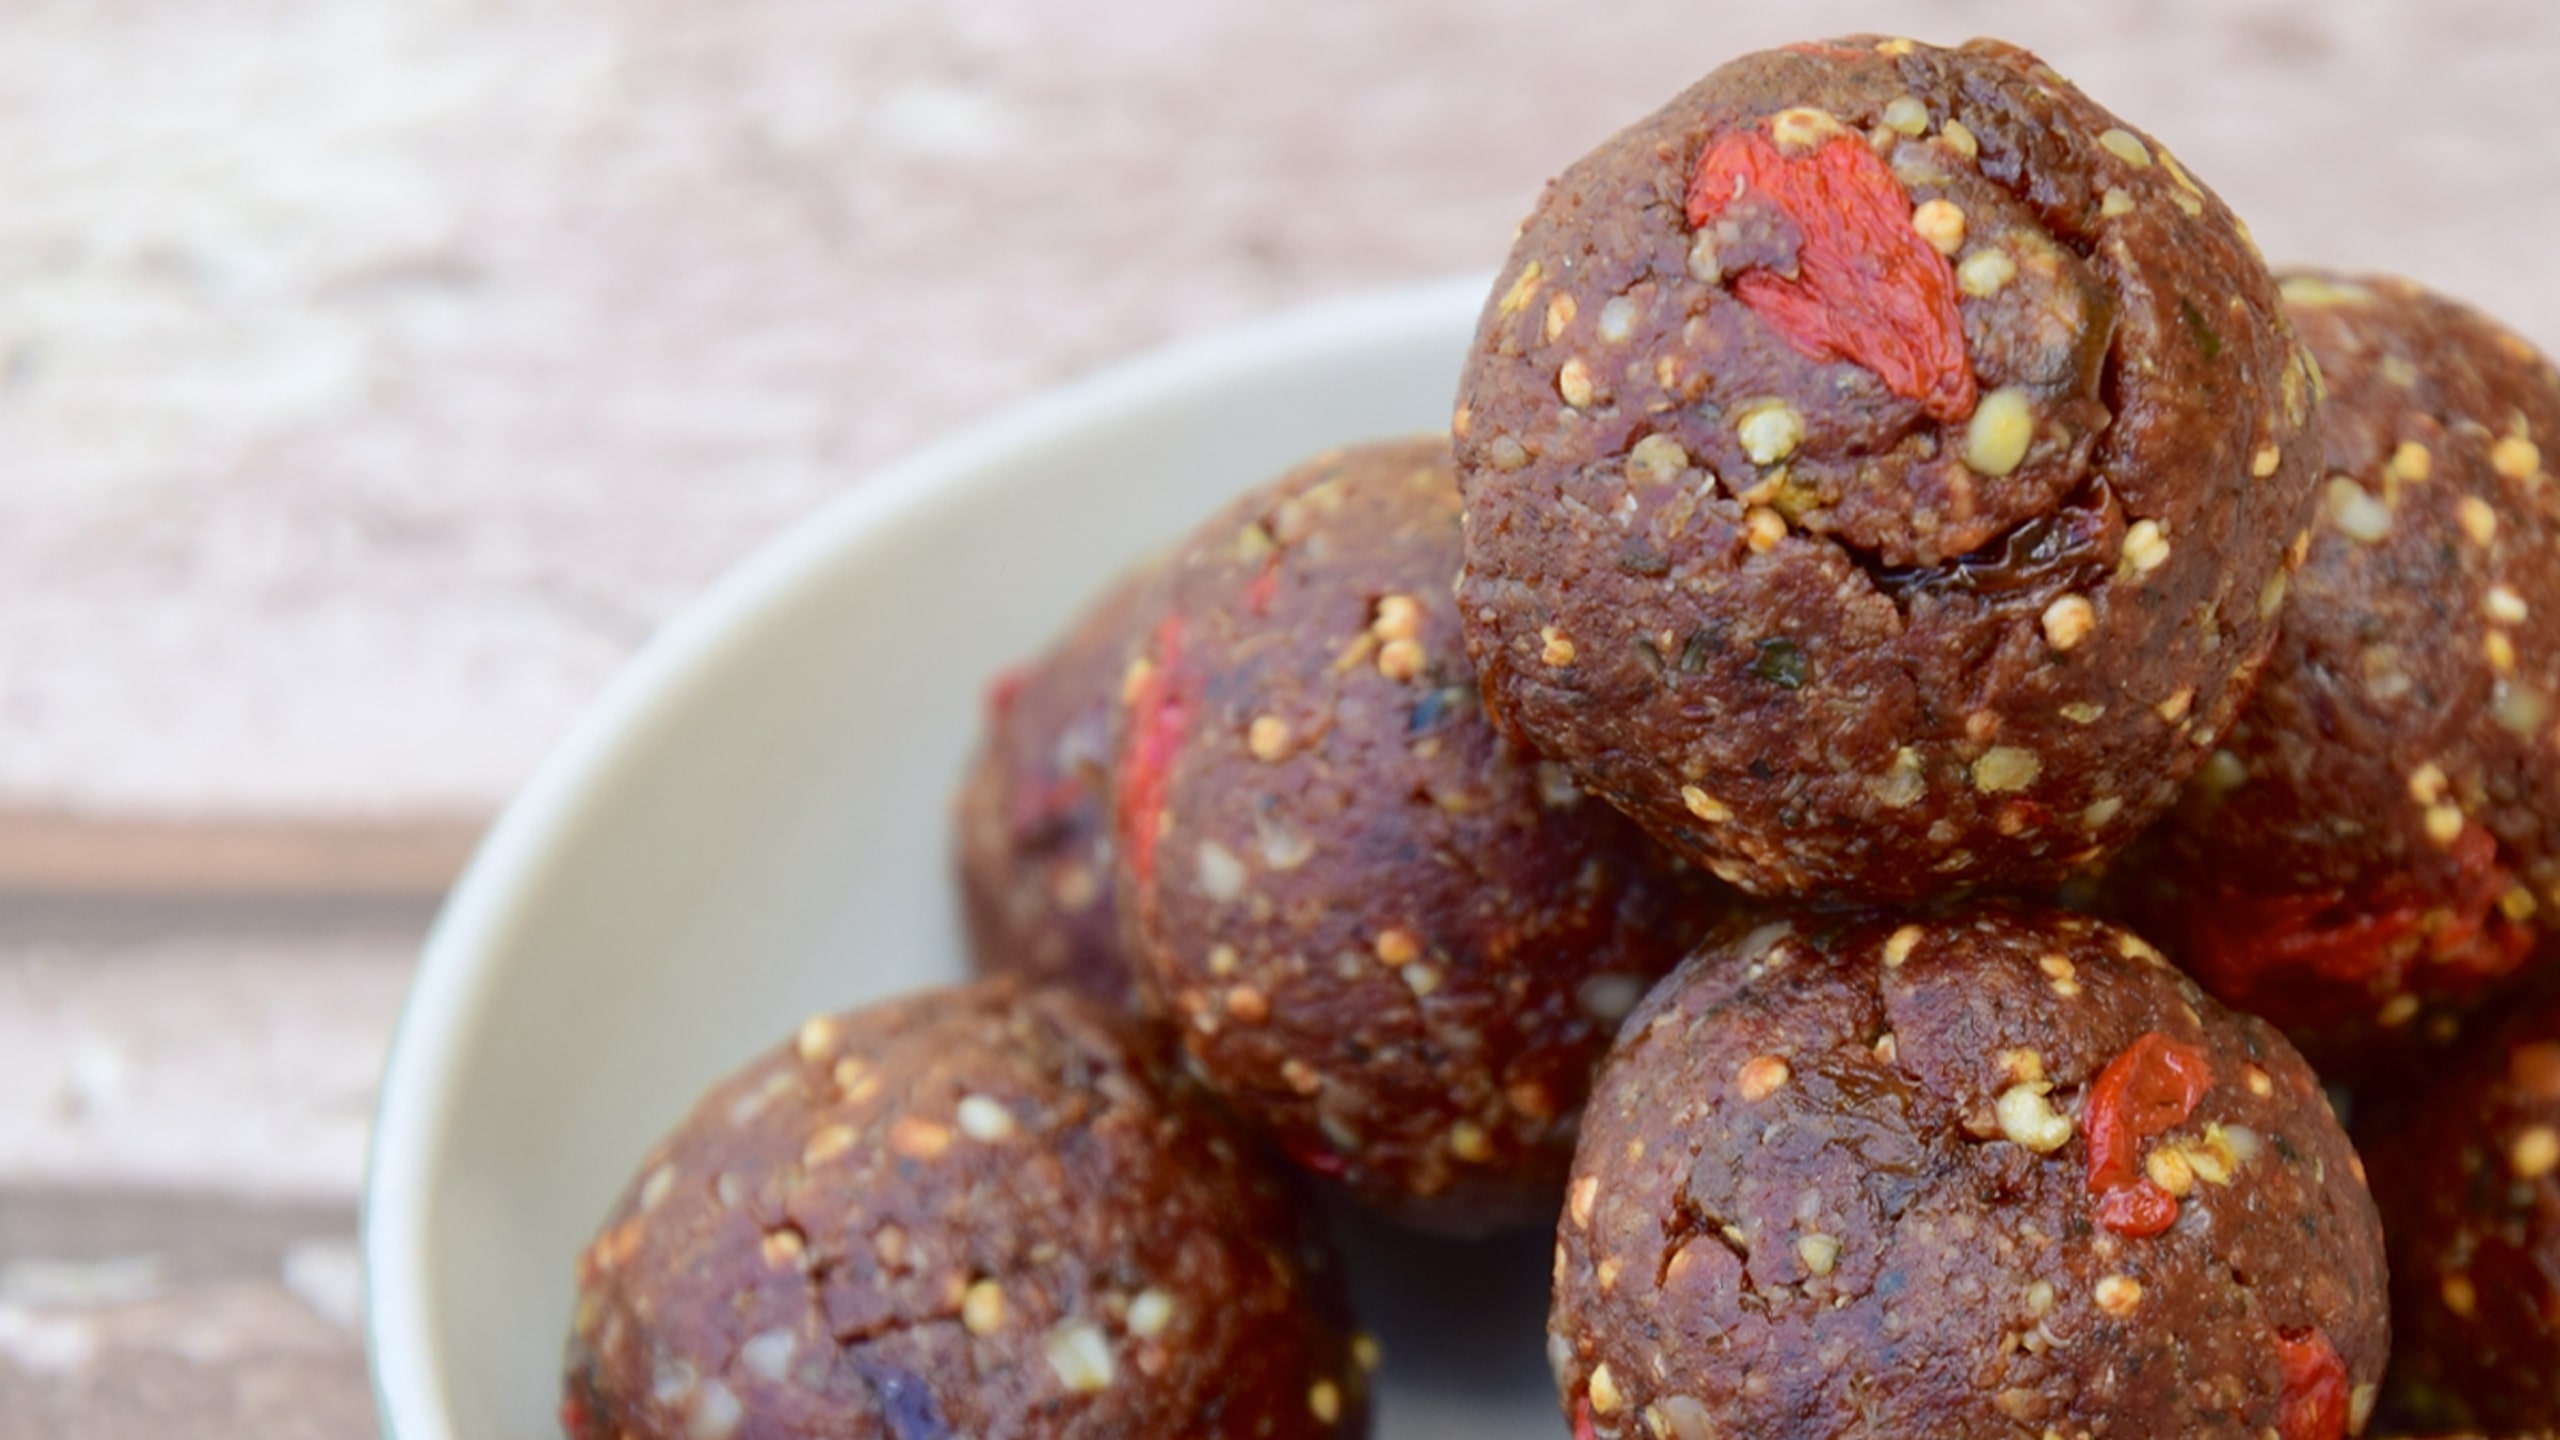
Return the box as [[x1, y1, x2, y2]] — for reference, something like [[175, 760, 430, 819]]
[[0, 0, 2560, 1440]]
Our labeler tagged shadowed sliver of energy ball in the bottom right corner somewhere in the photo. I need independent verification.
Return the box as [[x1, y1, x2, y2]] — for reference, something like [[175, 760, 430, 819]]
[[2365, 973, 2560, 1430]]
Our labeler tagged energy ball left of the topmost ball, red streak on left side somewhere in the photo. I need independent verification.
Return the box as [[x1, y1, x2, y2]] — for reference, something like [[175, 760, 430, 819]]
[[1116, 430, 1728, 1232]]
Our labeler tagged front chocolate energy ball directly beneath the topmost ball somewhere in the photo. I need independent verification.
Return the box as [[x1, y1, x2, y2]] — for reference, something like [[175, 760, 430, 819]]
[[1549, 910, 2388, 1440]]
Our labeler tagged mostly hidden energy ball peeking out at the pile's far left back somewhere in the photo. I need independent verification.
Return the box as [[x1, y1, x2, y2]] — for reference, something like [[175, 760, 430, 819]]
[[957, 571, 1149, 1007]]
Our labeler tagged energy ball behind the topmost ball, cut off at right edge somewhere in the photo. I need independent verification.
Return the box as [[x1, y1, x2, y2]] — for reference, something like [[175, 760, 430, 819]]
[[2120, 272, 2560, 1063]]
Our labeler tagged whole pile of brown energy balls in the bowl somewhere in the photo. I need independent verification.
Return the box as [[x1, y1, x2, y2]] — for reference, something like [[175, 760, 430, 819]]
[[563, 36, 2560, 1440]]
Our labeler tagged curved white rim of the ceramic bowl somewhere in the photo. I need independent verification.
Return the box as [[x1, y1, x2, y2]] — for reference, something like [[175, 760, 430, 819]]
[[358, 272, 1492, 1440]]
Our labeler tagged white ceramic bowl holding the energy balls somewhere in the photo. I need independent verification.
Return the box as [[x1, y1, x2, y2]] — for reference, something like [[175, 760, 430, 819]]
[[364, 279, 1562, 1440]]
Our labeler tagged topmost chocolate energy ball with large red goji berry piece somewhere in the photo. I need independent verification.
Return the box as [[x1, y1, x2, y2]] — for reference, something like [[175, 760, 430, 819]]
[[1454, 36, 2317, 899]]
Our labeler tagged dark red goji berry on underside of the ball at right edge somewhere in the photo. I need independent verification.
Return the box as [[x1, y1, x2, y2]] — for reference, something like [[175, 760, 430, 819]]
[[2186, 825, 2534, 1025]]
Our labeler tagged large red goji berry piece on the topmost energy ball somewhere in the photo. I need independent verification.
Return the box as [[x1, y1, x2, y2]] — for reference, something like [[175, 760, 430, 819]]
[[1687, 131, 1974, 420]]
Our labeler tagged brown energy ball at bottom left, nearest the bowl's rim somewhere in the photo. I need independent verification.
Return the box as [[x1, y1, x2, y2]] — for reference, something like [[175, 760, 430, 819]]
[[561, 981, 1367, 1440]]
